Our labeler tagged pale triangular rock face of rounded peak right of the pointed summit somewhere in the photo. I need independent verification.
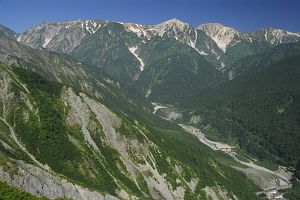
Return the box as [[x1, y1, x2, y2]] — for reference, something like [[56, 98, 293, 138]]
[[197, 23, 240, 52]]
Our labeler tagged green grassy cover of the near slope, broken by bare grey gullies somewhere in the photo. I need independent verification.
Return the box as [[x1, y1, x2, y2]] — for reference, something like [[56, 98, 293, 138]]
[[0, 65, 257, 199]]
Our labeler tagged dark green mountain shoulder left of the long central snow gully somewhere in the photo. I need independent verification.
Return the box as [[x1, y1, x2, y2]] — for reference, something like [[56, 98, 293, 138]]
[[71, 23, 142, 82]]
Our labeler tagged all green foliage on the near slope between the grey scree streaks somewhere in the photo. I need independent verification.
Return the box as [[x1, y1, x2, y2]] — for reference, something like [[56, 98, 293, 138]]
[[0, 64, 262, 199]]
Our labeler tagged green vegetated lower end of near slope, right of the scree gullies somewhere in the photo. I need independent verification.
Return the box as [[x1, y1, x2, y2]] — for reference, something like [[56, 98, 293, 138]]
[[147, 127, 259, 200]]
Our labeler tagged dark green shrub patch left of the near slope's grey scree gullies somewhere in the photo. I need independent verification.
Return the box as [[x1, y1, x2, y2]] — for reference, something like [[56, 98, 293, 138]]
[[4, 68, 117, 194]]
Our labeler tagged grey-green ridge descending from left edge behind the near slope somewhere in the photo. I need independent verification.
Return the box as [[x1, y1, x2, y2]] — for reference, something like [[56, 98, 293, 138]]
[[0, 35, 158, 126]]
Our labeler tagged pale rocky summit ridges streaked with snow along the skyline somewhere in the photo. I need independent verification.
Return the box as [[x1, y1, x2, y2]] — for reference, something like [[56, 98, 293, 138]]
[[17, 18, 300, 59]]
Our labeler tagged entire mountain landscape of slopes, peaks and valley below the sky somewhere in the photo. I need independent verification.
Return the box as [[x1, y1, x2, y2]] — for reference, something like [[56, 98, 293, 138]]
[[0, 19, 300, 199]]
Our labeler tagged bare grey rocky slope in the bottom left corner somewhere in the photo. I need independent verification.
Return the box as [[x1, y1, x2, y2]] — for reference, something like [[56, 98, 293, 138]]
[[0, 161, 117, 200]]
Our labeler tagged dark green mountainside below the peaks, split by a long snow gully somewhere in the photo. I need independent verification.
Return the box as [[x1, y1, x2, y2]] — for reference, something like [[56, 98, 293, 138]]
[[72, 23, 223, 103]]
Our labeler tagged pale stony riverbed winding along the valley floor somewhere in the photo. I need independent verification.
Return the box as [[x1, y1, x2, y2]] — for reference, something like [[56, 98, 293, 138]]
[[153, 104, 293, 200]]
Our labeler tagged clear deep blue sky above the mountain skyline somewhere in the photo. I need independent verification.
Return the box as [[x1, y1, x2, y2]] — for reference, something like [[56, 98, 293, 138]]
[[0, 0, 300, 32]]
